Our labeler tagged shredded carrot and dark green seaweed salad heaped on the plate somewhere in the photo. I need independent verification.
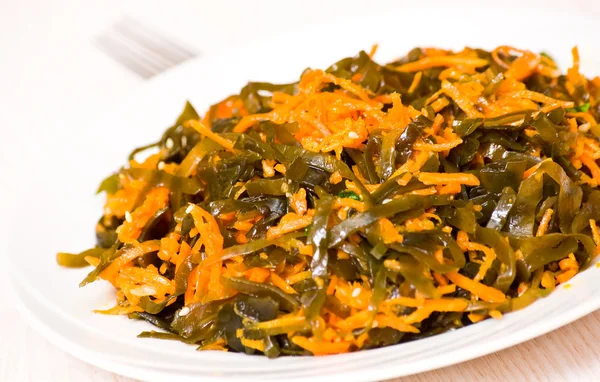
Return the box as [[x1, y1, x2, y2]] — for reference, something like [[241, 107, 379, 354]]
[[57, 46, 600, 357]]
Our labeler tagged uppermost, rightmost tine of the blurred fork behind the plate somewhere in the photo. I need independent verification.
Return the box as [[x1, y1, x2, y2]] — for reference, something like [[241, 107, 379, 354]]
[[115, 16, 197, 64]]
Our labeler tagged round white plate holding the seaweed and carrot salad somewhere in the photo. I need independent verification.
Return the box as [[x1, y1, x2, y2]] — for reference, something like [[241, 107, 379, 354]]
[[7, 8, 600, 380]]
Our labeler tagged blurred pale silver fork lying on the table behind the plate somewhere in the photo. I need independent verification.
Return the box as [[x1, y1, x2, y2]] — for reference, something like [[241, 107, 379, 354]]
[[93, 16, 199, 78]]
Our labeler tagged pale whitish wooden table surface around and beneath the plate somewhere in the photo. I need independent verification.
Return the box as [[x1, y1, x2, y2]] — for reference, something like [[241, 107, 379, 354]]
[[0, 0, 600, 382]]
